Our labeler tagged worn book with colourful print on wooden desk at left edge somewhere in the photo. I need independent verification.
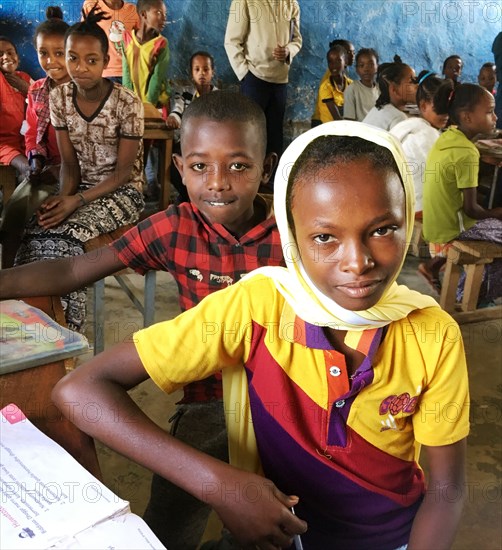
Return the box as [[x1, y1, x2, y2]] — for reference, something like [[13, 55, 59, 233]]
[[0, 300, 89, 374]]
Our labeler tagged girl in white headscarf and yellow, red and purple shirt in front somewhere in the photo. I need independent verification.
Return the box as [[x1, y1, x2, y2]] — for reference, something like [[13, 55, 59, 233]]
[[53, 121, 469, 550]]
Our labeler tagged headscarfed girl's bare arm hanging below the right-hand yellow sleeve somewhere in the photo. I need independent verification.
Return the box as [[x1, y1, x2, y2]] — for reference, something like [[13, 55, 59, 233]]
[[408, 439, 467, 550]]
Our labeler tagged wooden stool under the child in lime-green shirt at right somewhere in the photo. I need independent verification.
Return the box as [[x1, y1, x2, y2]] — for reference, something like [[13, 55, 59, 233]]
[[439, 241, 502, 322]]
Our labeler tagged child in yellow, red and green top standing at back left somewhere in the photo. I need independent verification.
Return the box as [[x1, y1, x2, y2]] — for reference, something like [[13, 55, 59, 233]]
[[122, 0, 170, 200]]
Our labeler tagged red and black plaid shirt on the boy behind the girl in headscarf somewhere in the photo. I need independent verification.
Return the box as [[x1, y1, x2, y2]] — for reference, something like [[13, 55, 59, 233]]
[[110, 196, 284, 403]]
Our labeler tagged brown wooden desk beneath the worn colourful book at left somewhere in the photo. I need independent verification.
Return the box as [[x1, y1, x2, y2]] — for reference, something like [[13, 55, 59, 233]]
[[0, 296, 101, 479]]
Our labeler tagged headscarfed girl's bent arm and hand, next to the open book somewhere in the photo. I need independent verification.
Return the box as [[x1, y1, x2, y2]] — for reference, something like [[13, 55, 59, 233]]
[[52, 343, 306, 549]]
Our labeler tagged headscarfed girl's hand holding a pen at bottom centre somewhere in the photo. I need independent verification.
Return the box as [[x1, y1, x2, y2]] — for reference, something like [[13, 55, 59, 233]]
[[207, 470, 307, 550]]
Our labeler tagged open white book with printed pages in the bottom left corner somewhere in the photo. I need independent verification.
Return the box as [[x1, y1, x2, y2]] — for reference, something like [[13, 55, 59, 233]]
[[0, 404, 165, 550]]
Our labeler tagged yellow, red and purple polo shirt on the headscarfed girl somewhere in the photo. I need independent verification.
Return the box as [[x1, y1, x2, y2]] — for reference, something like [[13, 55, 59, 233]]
[[135, 275, 469, 550]]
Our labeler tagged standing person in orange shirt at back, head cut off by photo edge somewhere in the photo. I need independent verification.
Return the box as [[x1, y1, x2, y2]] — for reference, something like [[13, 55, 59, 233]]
[[82, 0, 139, 84]]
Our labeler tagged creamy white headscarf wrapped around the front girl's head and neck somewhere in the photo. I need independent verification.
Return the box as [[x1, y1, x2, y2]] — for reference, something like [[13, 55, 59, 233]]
[[247, 121, 437, 331]]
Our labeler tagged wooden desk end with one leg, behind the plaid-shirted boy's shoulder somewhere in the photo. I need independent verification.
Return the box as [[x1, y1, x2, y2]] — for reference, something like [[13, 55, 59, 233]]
[[143, 103, 174, 210]]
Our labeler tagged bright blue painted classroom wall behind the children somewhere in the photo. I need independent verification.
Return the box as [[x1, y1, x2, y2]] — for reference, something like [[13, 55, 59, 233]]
[[0, 0, 502, 140]]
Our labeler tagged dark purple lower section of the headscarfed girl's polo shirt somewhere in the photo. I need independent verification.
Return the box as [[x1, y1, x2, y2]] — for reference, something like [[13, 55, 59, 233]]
[[249, 384, 421, 550]]
